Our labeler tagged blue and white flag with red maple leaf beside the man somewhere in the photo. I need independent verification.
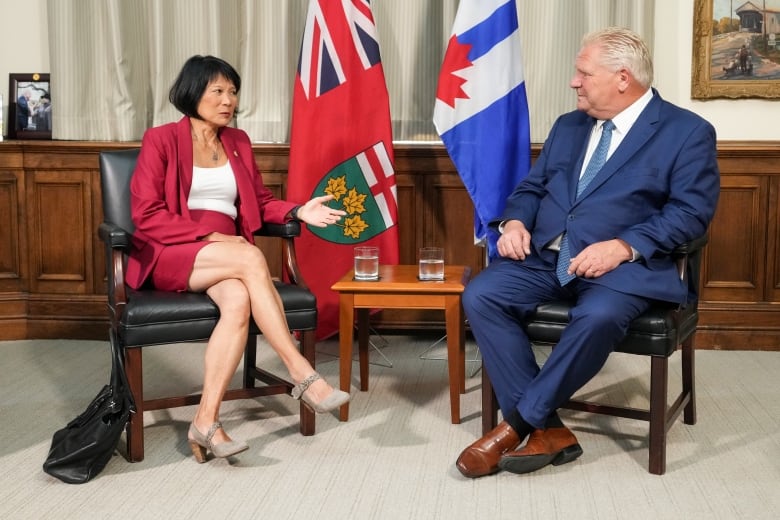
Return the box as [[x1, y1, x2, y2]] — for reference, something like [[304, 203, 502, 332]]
[[433, 0, 531, 259]]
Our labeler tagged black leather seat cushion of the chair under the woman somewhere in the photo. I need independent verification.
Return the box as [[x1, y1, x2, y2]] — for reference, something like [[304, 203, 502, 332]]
[[120, 282, 317, 347]]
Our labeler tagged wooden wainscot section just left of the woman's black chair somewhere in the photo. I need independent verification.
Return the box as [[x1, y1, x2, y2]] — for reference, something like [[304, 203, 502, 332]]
[[24, 142, 109, 339]]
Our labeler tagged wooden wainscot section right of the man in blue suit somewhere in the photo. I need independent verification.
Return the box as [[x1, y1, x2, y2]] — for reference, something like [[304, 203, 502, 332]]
[[696, 142, 780, 350]]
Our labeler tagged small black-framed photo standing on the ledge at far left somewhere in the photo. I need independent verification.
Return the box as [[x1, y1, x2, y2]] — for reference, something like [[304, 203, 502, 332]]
[[8, 73, 52, 139]]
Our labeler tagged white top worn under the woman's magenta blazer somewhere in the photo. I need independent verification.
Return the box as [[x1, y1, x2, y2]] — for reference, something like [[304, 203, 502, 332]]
[[187, 161, 238, 220]]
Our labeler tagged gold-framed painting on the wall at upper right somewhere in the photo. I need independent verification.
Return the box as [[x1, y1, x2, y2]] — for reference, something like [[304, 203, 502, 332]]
[[691, 0, 780, 99]]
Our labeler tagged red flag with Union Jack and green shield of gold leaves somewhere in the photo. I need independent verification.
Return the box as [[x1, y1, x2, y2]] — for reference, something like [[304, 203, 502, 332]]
[[287, 0, 399, 338]]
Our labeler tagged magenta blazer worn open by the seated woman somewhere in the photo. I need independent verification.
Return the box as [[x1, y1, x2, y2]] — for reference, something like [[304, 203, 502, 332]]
[[126, 117, 295, 288]]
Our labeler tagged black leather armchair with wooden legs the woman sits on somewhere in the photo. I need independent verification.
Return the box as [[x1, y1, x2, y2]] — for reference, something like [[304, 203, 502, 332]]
[[98, 149, 317, 462]]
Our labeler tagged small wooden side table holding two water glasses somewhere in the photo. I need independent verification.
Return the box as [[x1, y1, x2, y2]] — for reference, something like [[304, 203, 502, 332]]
[[331, 265, 471, 424]]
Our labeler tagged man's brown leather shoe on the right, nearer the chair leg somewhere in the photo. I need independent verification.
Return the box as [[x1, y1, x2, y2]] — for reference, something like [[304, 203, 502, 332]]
[[498, 426, 582, 473]]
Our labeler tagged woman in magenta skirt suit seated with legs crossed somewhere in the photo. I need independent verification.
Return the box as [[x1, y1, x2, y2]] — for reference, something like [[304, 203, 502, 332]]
[[127, 56, 349, 462]]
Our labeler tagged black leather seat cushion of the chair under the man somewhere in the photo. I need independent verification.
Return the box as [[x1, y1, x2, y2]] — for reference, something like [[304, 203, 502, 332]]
[[526, 301, 699, 357]]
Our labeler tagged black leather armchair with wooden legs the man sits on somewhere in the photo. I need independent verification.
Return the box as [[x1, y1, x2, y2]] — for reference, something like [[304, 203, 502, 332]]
[[482, 235, 707, 475]]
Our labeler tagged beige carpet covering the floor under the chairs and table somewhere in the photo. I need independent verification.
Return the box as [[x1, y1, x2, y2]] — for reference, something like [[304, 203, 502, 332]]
[[0, 336, 780, 520]]
